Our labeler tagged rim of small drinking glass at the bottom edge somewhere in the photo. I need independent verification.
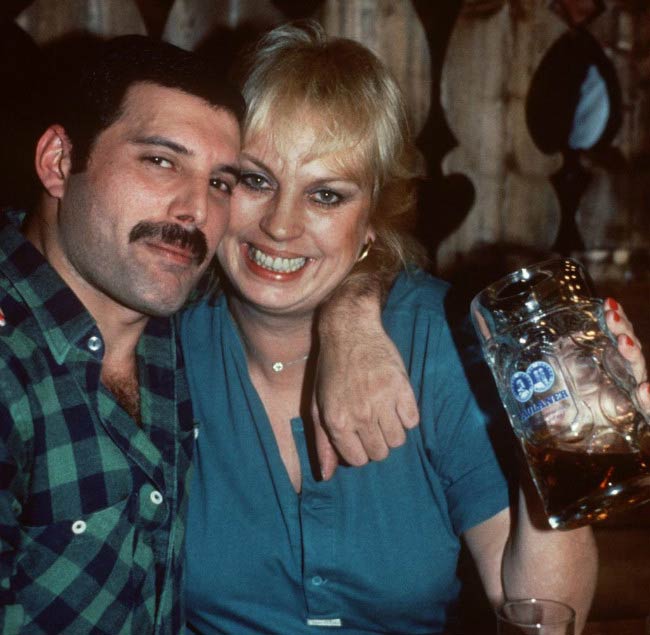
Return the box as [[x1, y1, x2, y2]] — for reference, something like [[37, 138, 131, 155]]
[[497, 598, 576, 635]]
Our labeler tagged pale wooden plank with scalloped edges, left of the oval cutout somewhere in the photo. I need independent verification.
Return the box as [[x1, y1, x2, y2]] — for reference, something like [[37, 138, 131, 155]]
[[438, 3, 567, 272]]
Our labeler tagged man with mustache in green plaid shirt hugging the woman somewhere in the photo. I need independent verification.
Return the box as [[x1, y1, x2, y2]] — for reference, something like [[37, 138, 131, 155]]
[[0, 36, 417, 635]]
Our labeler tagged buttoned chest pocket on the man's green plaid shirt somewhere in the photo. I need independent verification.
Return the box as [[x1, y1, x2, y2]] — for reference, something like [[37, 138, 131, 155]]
[[14, 497, 136, 633]]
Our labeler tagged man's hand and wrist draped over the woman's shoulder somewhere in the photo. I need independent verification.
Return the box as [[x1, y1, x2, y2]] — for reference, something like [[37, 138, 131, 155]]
[[312, 273, 418, 478]]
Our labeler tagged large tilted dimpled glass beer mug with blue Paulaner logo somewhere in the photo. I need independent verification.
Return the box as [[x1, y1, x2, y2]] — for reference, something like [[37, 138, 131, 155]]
[[471, 259, 650, 529]]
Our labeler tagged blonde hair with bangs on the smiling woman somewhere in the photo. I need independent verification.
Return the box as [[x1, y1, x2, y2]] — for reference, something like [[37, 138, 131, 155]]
[[242, 21, 425, 274]]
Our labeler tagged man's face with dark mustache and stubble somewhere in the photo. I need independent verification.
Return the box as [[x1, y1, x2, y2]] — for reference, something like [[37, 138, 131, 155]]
[[48, 83, 239, 315]]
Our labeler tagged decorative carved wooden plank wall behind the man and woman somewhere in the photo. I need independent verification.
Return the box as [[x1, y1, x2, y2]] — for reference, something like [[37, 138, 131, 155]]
[[9, 0, 650, 284]]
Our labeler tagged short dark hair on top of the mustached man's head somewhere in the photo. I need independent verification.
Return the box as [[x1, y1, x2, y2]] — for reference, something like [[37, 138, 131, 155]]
[[57, 35, 245, 172]]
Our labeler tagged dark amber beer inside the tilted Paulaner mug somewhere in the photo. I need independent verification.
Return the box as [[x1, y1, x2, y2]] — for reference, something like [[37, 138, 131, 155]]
[[524, 442, 650, 529]]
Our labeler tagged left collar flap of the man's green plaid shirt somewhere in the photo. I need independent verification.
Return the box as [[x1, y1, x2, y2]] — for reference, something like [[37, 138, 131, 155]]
[[0, 211, 97, 364]]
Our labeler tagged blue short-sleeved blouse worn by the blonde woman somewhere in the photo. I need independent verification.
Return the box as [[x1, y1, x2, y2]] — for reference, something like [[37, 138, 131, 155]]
[[182, 272, 508, 635]]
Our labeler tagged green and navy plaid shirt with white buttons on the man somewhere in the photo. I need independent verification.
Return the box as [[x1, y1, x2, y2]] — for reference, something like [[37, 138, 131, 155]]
[[0, 215, 194, 635]]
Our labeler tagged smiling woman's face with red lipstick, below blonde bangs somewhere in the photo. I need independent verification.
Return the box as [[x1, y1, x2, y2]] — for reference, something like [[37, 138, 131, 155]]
[[217, 124, 374, 315]]
